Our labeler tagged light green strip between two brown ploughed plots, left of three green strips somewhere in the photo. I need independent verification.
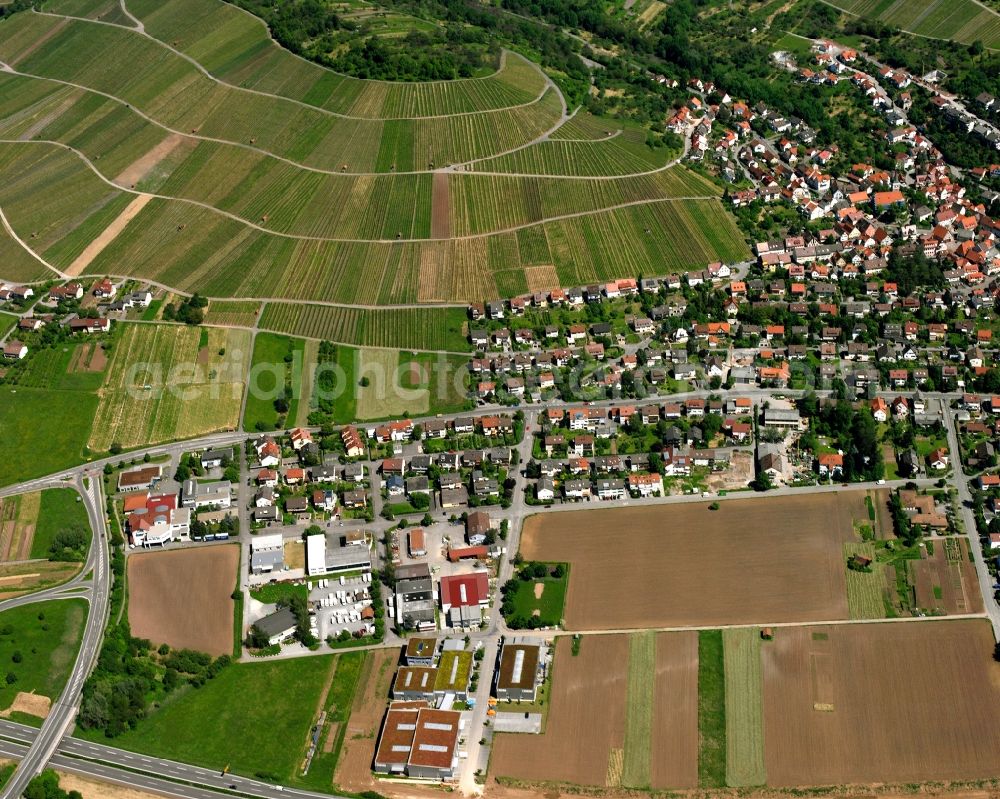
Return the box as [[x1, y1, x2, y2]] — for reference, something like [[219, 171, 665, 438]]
[[622, 631, 656, 788]]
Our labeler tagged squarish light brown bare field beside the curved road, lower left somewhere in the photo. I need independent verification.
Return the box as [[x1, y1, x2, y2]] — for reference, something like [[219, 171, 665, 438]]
[[128, 545, 240, 655]]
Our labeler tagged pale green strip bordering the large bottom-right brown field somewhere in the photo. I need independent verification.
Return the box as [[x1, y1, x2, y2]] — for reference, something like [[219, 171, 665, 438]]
[[722, 627, 767, 788]]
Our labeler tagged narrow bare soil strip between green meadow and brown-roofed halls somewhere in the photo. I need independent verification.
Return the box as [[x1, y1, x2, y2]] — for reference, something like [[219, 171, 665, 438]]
[[336, 649, 399, 793]]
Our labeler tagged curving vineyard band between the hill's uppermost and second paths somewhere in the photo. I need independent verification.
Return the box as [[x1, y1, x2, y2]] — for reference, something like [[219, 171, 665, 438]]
[[0, 14, 566, 173]]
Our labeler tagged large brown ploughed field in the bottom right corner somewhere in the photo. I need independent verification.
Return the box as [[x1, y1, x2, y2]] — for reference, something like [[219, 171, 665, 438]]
[[761, 620, 1000, 787]]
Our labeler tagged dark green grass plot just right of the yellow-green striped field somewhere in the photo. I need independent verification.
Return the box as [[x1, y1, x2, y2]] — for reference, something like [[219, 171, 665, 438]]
[[243, 333, 305, 430]]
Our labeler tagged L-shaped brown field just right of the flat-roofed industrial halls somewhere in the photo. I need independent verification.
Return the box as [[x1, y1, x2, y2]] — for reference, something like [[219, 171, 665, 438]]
[[490, 635, 624, 786]]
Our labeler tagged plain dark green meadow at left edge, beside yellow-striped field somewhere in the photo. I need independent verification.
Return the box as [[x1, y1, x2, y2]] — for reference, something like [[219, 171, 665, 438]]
[[0, 386, 97, 485]]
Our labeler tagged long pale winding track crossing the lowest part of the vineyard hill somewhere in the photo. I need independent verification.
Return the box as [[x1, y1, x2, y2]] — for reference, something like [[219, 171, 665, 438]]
[[0, 139, 716, 244]]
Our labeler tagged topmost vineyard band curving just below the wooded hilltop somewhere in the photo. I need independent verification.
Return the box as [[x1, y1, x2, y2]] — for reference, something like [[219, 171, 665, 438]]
[[122, 0, 546, 118]]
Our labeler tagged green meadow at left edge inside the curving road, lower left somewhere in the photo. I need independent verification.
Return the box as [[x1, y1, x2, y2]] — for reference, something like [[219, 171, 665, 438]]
[[0, 599, 87, 709]]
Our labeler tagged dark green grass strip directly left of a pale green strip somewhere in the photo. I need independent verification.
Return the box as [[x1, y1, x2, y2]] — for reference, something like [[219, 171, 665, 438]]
[[698, 630, 726, 788]]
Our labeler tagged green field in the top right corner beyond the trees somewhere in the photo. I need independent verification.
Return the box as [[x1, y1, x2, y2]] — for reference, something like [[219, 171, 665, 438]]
[[829, 0, 1000, 48]]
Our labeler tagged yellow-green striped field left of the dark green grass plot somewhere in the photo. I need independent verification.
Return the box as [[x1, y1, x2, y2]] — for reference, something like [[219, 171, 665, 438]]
[[90, 324, 250, 451]]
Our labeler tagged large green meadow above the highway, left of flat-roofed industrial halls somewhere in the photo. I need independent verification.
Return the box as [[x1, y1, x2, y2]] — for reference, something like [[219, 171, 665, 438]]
[[102, 653, 346, 788]]
